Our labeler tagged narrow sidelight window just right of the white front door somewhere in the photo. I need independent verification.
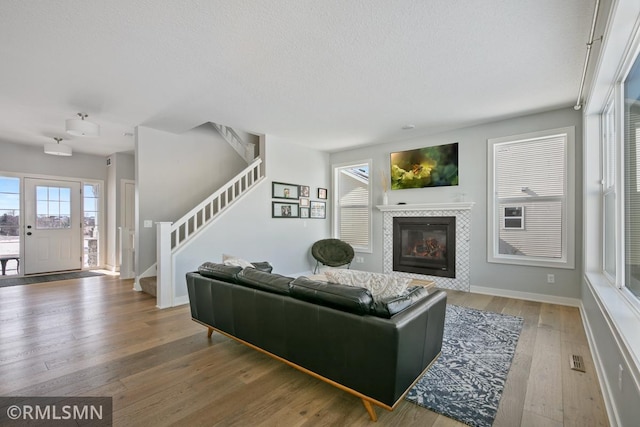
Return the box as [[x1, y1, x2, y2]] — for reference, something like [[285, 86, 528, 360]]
[[82, 183, 101, 267]]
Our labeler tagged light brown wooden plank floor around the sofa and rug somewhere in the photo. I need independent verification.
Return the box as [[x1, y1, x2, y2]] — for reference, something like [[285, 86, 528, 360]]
[[0, 276, 608, 427]]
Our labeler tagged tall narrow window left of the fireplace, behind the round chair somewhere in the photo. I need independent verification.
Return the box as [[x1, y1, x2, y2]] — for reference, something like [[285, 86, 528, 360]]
[[334, 161, 371, 252]]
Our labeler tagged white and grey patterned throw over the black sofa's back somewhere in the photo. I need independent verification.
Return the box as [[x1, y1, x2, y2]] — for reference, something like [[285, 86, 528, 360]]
[[324, 269, 411, 300]]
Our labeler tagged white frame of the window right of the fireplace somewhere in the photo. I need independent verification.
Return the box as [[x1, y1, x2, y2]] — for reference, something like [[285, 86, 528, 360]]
[[487, 126, 575, 269]]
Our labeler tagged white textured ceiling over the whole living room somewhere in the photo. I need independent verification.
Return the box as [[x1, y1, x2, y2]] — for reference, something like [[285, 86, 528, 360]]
[[0, 0, 594, 155]]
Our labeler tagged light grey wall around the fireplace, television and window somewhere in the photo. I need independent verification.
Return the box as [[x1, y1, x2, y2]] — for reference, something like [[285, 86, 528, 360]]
[[331, 107, 582, 299]]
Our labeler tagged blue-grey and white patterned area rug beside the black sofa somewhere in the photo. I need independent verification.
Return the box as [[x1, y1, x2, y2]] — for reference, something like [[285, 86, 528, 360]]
[[406, 305, 523, 427]]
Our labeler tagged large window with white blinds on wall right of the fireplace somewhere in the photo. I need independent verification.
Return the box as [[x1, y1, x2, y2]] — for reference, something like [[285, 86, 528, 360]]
[[488, 128, 573, 268]]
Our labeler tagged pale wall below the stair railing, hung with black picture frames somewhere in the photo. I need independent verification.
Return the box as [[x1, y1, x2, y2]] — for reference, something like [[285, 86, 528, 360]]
[[174, 136, 330, 299]]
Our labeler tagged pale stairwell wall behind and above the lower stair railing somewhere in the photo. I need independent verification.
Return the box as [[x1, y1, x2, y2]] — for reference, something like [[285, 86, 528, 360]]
[[135, 125, 252, 275]]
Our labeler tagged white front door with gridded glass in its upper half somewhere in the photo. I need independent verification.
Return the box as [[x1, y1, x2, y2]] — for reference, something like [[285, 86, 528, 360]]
[[23, 178, 82, 274]]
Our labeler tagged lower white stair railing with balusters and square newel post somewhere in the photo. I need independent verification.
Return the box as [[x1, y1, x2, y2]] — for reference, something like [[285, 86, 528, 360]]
[[156, 158, 263, 308]]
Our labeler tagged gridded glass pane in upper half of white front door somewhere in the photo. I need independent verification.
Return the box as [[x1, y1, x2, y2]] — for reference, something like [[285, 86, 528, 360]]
[[36, 185, 71, 230]]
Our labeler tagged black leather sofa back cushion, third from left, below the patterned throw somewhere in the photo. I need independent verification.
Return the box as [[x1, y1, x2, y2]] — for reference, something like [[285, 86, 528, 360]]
[[290, 277, 373, 314]]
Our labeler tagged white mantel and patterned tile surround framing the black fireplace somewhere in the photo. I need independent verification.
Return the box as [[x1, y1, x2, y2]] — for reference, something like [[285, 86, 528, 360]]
[[377, 202, 474, 292]]
